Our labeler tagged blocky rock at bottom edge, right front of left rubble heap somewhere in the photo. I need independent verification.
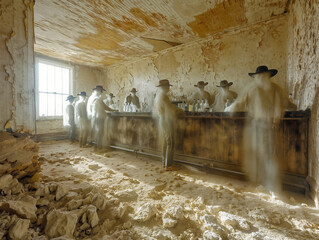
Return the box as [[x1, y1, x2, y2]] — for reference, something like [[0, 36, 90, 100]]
[[45, 210, 78, 238]]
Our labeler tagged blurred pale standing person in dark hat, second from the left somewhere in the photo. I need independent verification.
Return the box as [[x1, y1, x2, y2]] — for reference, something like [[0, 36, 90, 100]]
[[75, 92, 90, 147]]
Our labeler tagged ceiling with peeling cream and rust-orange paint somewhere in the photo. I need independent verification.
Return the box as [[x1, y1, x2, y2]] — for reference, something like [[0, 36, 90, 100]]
[[35, 0, 287, 66]]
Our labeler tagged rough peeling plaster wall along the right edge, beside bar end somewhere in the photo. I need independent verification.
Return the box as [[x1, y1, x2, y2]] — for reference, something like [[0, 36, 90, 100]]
[[287, 0, 319, 203]]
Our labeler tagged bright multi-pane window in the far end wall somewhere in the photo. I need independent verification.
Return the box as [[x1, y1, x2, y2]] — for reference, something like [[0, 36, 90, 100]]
[[36, 59, 72, 119]]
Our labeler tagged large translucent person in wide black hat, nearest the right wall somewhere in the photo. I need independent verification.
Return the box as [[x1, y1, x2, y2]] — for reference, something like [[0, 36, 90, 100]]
[[227, 66, 296, 192]]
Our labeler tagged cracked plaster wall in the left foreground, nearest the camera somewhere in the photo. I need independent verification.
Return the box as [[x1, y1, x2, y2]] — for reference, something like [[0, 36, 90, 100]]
[[0, 0, 35, 132]]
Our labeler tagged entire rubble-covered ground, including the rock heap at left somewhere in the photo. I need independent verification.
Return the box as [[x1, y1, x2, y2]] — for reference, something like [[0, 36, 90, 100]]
[[0, 136, 319, 240]]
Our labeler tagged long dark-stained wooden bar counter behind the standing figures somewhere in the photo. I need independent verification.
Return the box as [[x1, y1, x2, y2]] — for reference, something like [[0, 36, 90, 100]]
[[107, 110, 310, 193]]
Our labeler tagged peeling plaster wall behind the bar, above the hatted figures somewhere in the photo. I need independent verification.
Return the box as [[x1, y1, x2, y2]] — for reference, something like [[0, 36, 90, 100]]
[[104, 15, 288, 108]]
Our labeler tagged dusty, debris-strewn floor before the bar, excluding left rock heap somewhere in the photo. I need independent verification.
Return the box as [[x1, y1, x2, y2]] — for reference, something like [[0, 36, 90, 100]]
[[40, 141, 319, 240]]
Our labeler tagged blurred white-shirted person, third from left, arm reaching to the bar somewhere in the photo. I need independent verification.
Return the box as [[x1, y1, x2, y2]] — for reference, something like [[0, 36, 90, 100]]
[[89, 86, 114, 149]]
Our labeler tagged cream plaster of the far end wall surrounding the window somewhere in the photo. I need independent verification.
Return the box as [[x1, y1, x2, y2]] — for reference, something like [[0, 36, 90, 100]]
[[36, 55, 102, 134]]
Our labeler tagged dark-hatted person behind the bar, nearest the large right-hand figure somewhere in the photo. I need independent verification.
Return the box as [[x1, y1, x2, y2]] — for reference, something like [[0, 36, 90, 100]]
[[213, 80, 237, 112]]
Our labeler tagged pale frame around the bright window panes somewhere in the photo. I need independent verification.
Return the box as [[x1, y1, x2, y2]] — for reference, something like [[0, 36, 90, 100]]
[[35, 57, 74, 120]]
